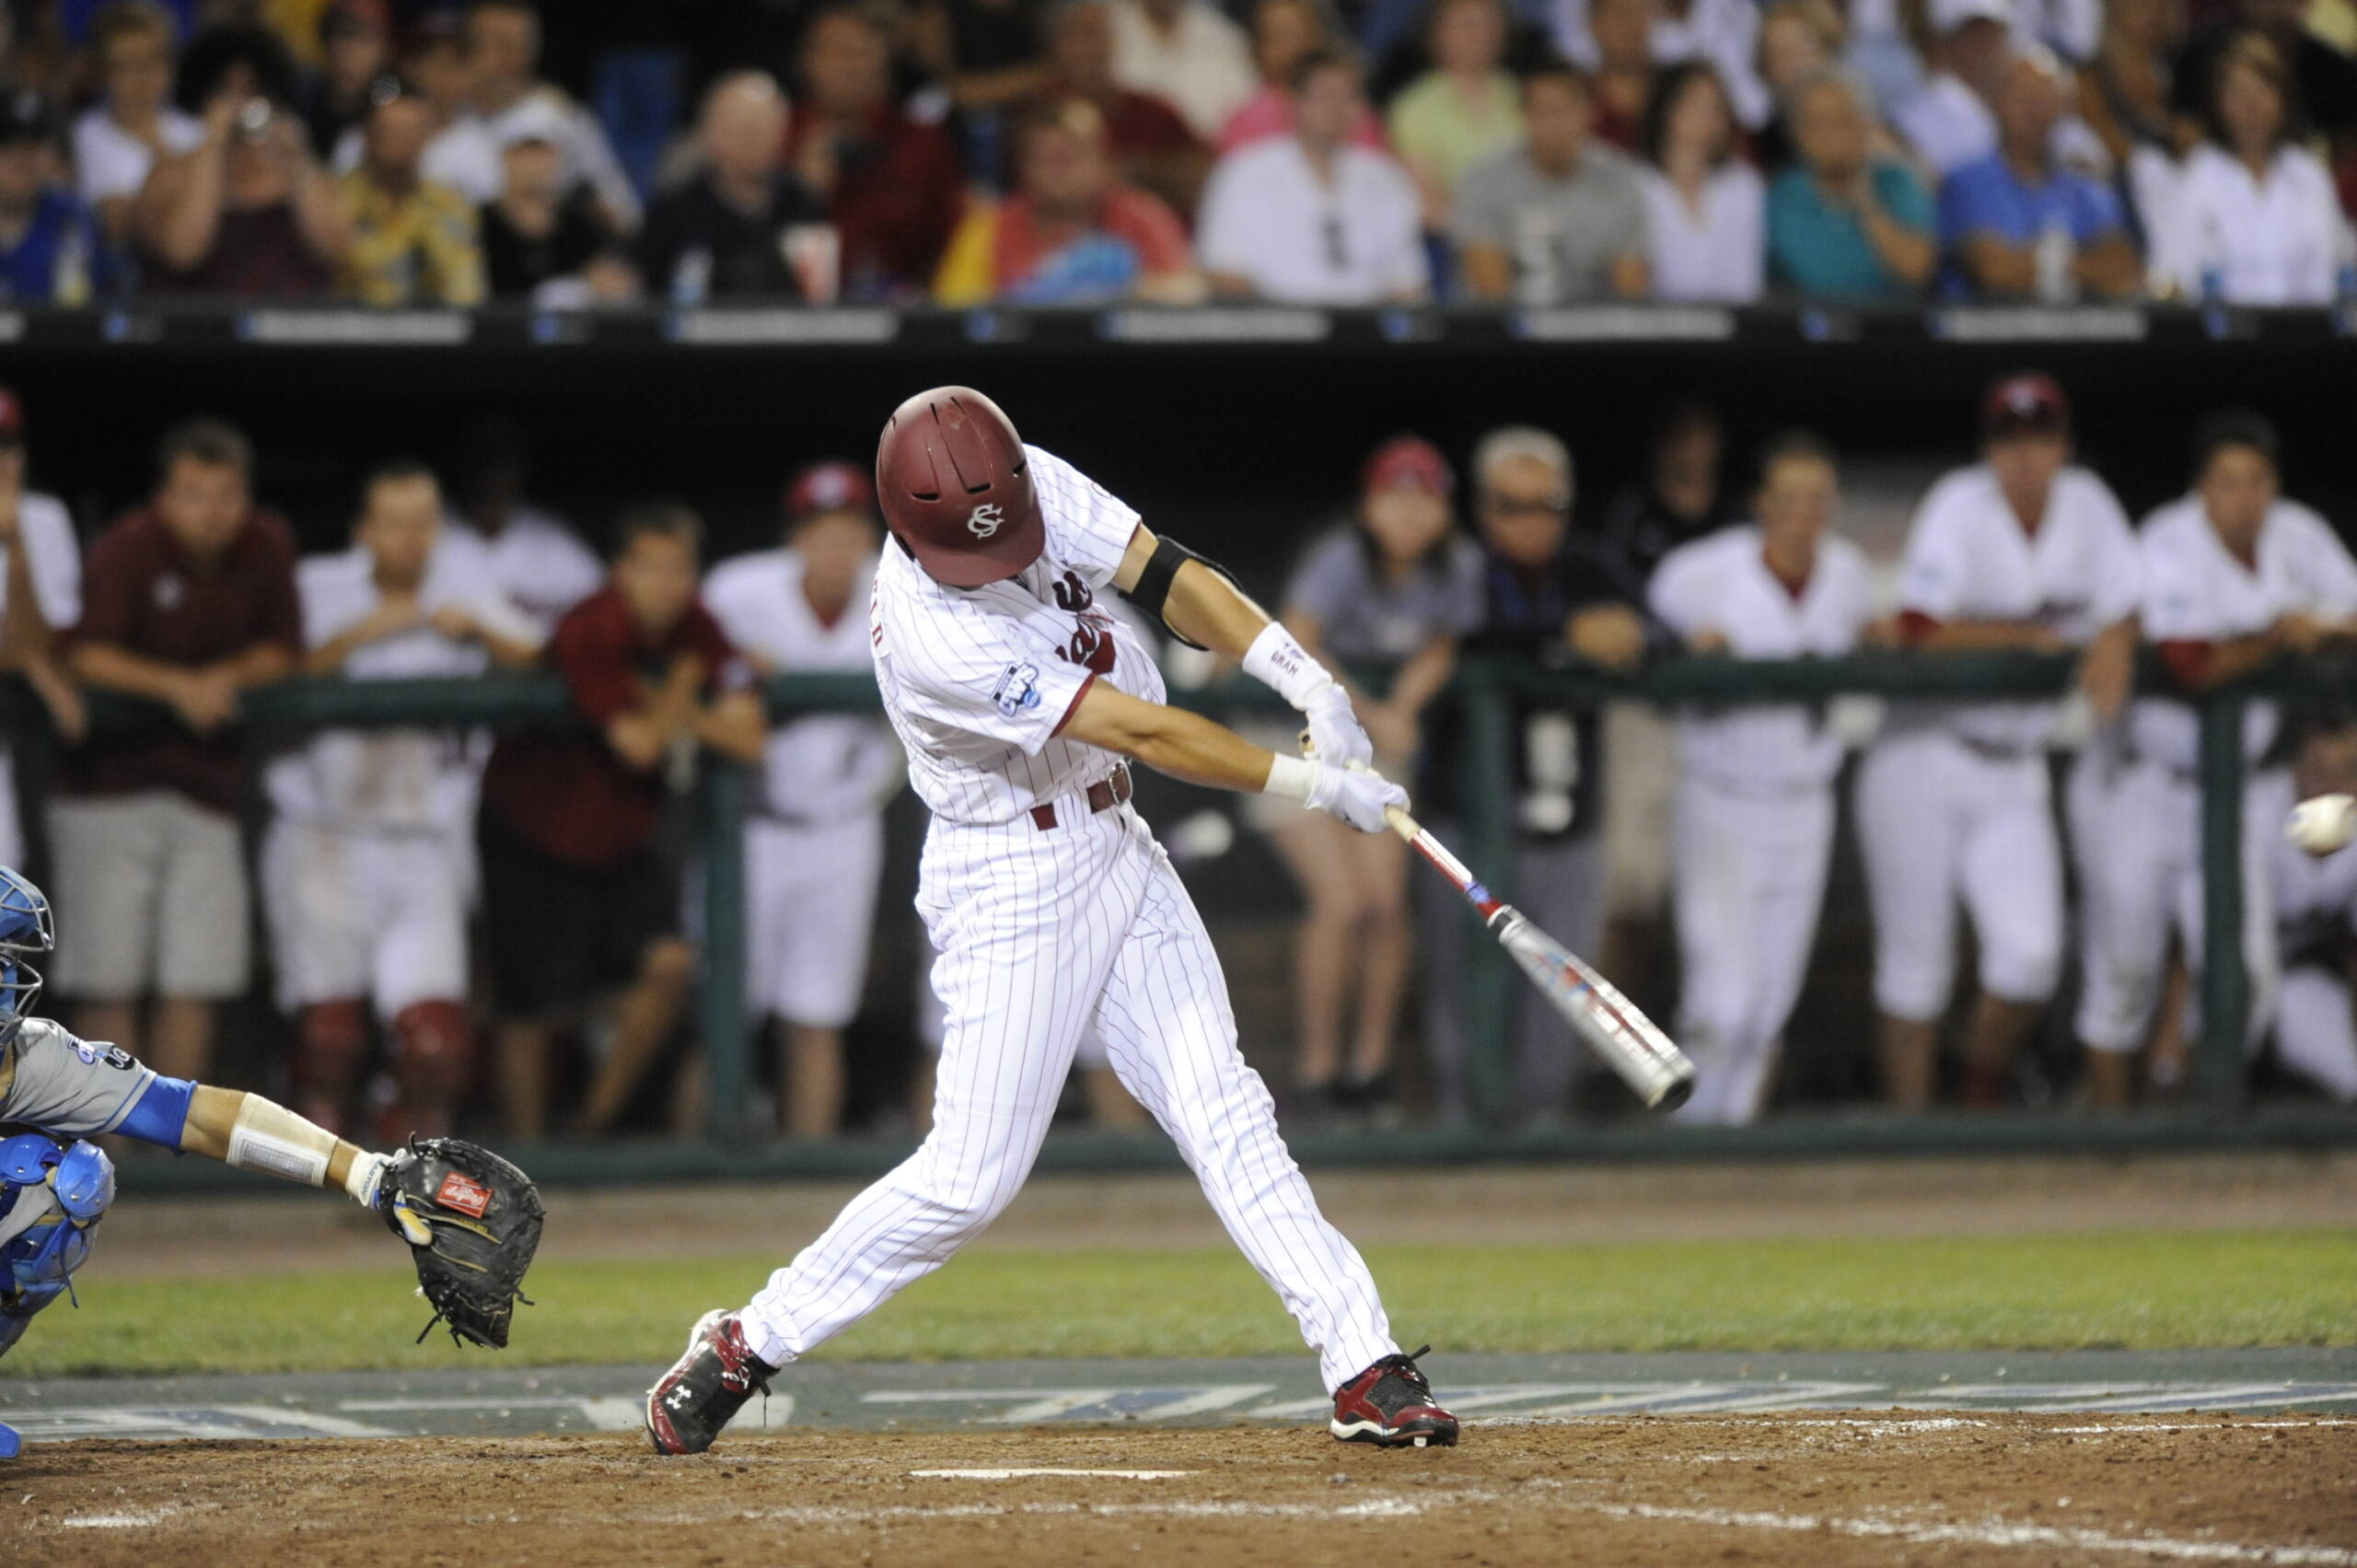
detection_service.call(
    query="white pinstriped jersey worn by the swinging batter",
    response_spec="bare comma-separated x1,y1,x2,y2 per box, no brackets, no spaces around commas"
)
870,446,1165,825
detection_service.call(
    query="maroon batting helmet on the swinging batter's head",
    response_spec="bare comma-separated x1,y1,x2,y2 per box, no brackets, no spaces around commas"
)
877,387,1047,587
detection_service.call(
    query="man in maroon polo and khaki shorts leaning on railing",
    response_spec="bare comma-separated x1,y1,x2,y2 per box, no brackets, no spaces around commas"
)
50,420,302,1077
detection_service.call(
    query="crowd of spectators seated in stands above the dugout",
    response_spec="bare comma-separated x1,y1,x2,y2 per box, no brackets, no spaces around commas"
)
0,0,2357,308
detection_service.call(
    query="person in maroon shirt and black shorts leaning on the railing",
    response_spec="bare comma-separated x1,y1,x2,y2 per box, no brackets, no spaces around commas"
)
476,505,763,1139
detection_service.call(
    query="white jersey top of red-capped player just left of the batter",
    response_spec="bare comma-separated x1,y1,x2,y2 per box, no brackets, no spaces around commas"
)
704,550,900,823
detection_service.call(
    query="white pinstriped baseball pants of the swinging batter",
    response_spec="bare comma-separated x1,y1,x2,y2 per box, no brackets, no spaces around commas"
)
742,795,1400,1388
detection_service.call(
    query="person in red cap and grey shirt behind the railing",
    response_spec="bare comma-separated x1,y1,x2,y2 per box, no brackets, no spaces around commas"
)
1275,436,1480,1113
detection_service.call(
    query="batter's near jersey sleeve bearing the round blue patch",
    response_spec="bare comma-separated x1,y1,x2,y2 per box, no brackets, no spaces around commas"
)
884,594,1096,757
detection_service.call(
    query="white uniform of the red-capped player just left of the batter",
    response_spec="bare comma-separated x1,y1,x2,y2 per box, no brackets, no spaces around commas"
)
704,550,900,1028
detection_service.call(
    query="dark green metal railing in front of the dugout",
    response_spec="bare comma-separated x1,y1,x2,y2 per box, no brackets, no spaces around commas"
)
0,651,2357,1177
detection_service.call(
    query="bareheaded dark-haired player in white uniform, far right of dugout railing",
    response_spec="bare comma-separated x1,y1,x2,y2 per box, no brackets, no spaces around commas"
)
2079,412,2357,1110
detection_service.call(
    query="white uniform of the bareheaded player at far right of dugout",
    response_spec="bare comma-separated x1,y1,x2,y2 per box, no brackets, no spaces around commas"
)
2079,497,2357,1051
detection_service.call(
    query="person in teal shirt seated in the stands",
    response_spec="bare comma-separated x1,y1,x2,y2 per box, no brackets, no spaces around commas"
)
1768,71,1940,304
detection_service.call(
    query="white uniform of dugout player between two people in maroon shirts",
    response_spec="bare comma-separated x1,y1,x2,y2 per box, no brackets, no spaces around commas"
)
261,545,538,1018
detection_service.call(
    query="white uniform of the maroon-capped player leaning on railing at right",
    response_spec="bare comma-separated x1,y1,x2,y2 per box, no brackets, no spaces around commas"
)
1857,464,2140,1021
